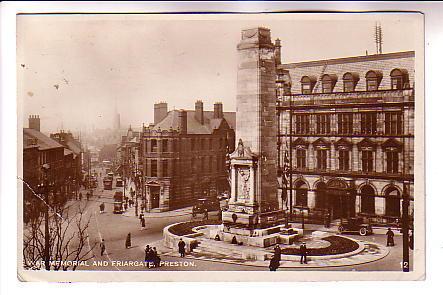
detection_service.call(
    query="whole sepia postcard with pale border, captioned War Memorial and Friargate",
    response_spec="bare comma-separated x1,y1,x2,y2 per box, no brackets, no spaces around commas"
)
15,12,425,282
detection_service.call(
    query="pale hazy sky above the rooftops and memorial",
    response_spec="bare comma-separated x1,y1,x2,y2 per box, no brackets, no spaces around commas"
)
17,14,422,132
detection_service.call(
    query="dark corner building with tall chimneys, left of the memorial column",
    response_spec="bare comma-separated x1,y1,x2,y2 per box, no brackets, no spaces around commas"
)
140,101,235,211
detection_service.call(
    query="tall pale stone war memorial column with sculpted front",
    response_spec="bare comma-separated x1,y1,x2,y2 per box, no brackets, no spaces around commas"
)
222,27,284,247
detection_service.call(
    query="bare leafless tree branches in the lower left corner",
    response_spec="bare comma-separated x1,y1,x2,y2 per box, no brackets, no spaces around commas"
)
23,206,97,270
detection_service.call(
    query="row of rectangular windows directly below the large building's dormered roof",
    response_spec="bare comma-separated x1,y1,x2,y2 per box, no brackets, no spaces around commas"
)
294,112,403,135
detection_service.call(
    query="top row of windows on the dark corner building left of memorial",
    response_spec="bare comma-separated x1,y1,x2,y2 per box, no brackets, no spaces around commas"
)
145,137,225,152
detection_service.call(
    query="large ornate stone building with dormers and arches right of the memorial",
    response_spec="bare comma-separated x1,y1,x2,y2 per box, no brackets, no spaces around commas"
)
275,40,415,223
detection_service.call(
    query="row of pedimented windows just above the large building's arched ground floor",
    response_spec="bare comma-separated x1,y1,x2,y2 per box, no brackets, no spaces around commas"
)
295,149,399,173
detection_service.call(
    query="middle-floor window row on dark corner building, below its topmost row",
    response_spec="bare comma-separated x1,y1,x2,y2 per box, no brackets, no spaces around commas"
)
145,157,226,177
